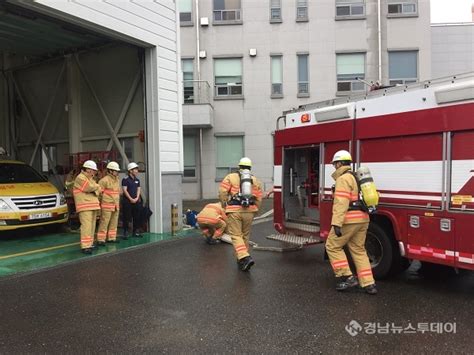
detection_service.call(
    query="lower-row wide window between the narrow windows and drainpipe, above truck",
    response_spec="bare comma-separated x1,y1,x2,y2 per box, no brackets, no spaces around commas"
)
336,53,365,92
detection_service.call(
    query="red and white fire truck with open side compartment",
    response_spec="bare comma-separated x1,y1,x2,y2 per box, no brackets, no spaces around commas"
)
273,72,474,279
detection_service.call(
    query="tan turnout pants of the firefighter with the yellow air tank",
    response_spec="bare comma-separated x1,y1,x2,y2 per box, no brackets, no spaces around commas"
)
326,223,375,287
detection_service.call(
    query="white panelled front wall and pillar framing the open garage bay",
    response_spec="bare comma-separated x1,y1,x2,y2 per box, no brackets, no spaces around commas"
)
22,0,183,232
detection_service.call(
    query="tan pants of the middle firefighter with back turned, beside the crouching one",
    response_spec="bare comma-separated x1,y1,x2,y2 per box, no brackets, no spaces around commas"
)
227,212,254,260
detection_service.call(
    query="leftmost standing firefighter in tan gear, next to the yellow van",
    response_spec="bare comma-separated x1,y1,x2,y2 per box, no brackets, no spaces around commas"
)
73,160,101,254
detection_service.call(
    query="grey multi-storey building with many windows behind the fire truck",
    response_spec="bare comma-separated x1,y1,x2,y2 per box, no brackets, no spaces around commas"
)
178,0,431,199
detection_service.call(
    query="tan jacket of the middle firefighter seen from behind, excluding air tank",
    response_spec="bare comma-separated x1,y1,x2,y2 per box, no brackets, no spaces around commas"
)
219,173,263,213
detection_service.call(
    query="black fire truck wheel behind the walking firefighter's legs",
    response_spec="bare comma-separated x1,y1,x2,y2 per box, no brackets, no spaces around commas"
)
365,223,397,280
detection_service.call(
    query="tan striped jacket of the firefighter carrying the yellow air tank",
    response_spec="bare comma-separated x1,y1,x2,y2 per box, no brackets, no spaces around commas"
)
331,166,370,227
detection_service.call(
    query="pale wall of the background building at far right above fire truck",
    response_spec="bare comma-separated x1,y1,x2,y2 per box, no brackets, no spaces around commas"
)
431,22,474,78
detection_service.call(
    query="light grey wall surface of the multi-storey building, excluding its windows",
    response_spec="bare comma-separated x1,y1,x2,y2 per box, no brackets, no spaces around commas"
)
181,0,431,199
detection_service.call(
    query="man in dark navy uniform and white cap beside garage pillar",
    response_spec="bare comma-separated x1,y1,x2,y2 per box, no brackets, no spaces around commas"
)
122,162,141,239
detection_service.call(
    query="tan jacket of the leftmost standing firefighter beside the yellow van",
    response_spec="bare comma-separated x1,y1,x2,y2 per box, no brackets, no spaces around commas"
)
72,172,100,212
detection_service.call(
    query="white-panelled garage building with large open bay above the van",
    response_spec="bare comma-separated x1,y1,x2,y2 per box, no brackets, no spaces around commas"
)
0,0,183,232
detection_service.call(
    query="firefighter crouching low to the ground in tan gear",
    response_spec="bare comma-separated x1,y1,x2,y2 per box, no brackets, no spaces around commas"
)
197,202,227,245
